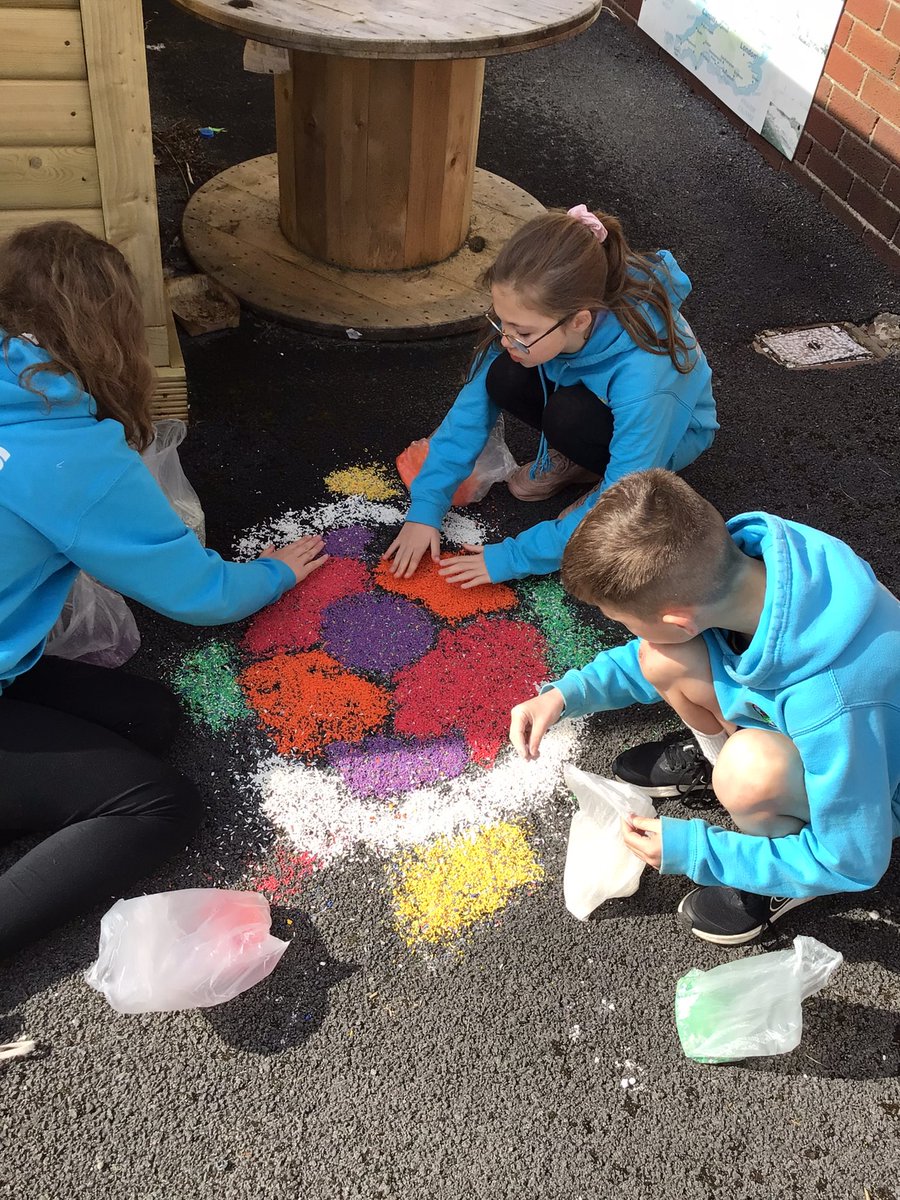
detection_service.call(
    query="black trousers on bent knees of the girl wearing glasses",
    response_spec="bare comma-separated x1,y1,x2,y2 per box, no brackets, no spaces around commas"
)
487,354,612,475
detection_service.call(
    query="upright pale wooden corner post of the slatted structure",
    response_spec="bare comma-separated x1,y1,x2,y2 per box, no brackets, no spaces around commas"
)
82,0,168,328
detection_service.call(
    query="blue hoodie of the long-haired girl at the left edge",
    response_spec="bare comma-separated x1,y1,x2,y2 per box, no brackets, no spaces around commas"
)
0,330,294,688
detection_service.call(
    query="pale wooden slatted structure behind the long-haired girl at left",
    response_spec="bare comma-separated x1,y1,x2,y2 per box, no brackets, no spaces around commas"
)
0,0,186,391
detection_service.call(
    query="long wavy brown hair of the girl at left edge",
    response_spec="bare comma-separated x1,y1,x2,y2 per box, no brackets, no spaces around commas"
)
0,221,155,450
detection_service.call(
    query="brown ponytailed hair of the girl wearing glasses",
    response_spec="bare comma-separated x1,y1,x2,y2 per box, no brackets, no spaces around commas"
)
469,212,696,377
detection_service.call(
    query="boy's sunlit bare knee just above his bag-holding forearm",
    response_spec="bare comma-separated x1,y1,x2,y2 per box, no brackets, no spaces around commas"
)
713,730,809,820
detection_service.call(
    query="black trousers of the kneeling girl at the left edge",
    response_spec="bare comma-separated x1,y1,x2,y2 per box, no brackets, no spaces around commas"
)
0,656,202,959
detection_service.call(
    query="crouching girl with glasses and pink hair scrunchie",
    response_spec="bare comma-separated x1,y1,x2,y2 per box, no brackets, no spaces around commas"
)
385,204,719,588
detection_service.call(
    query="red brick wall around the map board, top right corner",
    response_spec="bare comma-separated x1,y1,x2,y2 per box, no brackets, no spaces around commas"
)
605,0,900,270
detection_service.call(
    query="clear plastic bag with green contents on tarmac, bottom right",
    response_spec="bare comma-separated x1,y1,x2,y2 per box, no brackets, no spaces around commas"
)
676,937,844,1062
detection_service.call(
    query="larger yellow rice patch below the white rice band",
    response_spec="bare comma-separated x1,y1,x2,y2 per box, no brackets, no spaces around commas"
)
394,821,544,947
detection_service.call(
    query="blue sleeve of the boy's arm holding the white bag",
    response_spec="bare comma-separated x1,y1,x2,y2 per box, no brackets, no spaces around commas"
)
661,708,893,896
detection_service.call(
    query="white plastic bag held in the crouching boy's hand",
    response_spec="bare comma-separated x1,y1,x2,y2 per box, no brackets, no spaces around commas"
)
563,763,656,920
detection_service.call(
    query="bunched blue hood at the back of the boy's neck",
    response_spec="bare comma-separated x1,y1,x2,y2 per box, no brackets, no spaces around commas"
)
725,512,886,691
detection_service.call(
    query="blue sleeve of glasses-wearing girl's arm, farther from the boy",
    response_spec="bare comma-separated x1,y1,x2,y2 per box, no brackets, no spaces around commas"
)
407,353,500,529
